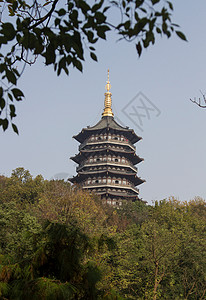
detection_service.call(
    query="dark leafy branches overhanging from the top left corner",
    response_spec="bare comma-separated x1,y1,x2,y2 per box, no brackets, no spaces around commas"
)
0,0,186,133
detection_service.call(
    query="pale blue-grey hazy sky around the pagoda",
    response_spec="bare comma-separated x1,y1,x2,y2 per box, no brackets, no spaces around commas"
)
0,0,206,203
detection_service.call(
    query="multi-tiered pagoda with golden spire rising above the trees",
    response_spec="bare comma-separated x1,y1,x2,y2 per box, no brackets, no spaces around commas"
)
69,70,144,206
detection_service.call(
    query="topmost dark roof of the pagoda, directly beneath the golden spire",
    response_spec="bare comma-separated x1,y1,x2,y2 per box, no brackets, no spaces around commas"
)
73,116,142,144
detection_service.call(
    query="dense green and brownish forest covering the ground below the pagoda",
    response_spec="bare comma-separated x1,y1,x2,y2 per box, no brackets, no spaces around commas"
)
0,168,206,300
